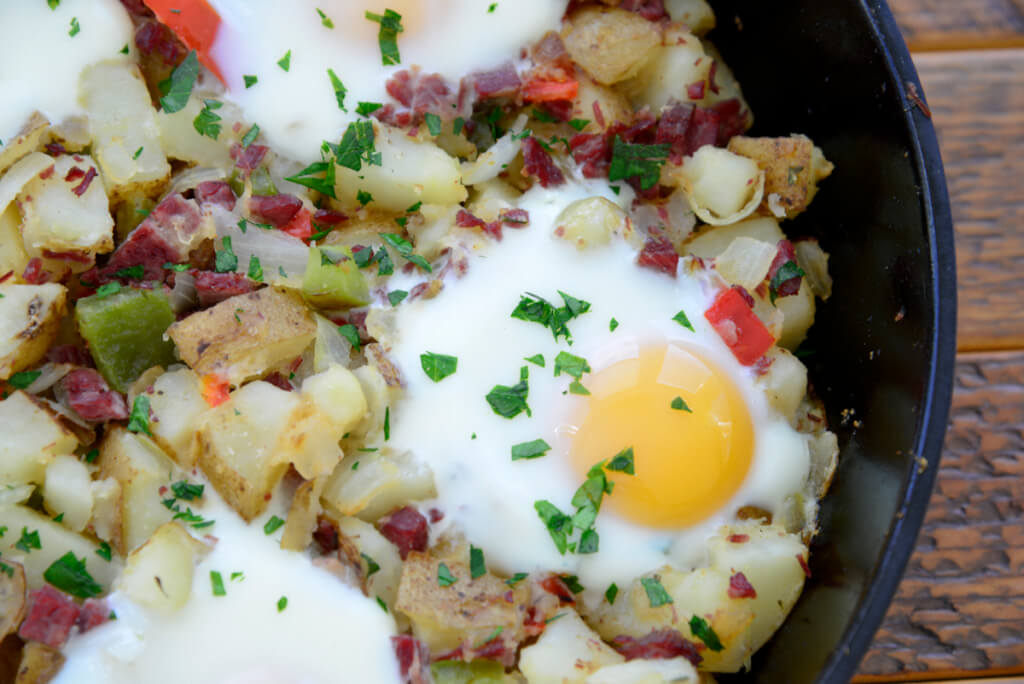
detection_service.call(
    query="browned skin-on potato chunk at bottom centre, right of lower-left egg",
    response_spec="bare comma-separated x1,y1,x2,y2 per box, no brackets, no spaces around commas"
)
394,546,529,653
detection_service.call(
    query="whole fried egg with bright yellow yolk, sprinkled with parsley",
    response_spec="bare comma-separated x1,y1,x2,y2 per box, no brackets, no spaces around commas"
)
388,181,809,592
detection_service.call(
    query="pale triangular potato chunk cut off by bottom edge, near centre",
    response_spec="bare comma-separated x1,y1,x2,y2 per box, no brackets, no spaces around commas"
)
519,608,626,684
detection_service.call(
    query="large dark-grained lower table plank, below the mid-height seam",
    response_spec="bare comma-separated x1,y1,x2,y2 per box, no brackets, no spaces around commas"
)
855,351,1024,682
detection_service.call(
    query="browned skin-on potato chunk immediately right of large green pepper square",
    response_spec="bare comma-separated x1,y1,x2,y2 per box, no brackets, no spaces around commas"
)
167,288,316,386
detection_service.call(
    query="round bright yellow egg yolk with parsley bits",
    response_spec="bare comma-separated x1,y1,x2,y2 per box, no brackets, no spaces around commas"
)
569,344,754,528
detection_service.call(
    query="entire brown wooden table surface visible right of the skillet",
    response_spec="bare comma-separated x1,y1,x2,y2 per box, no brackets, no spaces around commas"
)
855,0,1024,684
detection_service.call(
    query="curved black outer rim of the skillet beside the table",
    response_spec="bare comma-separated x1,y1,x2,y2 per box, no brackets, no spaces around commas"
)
817,0,956,682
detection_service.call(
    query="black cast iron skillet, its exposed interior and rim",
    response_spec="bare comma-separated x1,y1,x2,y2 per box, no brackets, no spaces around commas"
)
710,0,956,684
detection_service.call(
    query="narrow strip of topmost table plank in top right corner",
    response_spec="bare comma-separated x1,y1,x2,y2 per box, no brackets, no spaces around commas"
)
889,0,1024,51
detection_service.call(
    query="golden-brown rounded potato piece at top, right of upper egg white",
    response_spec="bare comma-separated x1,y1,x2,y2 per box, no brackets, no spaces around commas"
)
562,5,662,85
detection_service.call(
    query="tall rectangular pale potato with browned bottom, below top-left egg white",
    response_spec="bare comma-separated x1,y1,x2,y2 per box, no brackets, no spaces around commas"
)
79,61,171,198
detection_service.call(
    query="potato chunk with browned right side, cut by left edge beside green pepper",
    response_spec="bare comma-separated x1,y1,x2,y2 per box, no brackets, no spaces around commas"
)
0,283,68,378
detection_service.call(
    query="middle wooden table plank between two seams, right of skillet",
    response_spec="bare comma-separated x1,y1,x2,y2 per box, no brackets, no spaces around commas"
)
914,49,1024,350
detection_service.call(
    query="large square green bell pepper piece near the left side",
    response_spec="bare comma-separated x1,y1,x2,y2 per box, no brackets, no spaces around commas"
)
75,288,176,392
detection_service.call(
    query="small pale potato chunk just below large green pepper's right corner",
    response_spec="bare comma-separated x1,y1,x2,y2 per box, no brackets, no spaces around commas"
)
146,368,209,470
